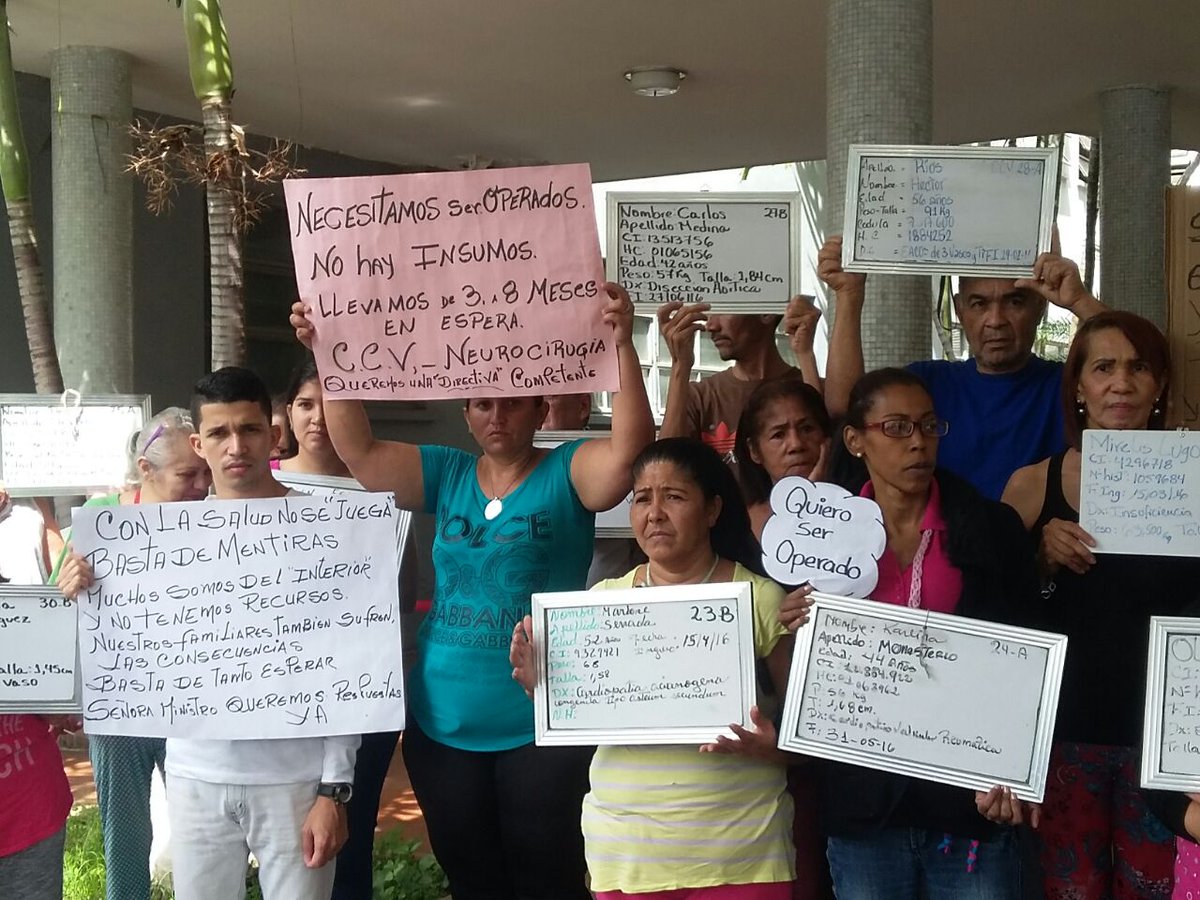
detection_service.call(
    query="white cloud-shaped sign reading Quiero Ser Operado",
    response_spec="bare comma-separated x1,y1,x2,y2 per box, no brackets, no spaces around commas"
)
762,475,888,598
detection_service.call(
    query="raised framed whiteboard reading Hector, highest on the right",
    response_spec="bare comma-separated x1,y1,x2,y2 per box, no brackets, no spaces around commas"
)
841,144,1058,278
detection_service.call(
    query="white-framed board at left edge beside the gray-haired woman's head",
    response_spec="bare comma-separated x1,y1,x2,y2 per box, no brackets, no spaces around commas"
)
0,394,150,497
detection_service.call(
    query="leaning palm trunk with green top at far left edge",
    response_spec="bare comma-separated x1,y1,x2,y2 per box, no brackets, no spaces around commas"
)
0,0,62,394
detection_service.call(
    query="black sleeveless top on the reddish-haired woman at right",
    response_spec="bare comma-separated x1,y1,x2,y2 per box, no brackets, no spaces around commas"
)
1032,454,1200,746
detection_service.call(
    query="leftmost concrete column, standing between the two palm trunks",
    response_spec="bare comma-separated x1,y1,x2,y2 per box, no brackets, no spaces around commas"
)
50,47,133,394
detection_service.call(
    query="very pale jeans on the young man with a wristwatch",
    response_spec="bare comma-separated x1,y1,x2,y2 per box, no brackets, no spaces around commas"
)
167,775,336,900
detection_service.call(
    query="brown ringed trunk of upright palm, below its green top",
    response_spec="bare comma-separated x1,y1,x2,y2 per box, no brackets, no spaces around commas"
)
203,96,246,370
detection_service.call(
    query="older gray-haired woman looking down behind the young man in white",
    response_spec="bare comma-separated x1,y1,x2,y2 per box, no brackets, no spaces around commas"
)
52,407,212,900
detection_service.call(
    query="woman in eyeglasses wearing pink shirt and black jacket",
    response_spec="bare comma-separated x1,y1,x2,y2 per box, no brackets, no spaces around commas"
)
780,368,1038,900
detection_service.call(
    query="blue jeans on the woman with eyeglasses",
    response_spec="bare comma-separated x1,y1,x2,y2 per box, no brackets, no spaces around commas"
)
828,828,1021,900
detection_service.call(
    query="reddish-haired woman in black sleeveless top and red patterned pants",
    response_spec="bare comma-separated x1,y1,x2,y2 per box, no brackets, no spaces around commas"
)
1003,311,1200,900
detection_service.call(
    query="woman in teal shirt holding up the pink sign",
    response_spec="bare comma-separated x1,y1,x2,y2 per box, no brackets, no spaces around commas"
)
292,284,654,900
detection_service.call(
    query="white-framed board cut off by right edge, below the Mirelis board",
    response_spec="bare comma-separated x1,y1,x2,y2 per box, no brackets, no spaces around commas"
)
1141,616,1200,791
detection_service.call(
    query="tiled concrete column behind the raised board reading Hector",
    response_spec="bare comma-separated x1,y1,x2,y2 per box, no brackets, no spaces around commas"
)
826,0,934,371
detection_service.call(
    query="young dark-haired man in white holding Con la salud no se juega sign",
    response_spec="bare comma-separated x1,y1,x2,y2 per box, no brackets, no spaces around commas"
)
60,367,359,900
